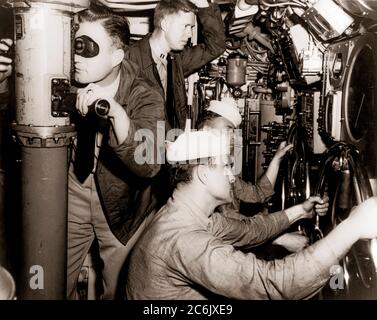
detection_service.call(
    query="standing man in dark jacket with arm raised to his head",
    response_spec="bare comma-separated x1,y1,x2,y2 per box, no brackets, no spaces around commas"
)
126,0,226,129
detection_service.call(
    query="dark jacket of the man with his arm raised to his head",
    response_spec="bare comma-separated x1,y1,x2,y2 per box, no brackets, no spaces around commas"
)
126,4,225,129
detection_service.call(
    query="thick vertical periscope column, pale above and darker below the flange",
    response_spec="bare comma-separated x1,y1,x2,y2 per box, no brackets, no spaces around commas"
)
11,0,89,300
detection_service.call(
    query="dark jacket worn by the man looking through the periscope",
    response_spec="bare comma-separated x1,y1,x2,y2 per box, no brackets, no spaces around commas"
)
72,60,164,244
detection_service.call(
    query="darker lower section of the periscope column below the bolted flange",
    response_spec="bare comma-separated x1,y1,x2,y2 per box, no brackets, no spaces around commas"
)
17,146,67,299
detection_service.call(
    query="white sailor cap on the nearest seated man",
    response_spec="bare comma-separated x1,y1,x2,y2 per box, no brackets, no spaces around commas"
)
166,131,230,162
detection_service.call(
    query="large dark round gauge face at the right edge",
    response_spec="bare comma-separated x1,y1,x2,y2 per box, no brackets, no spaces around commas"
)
346,47,377,141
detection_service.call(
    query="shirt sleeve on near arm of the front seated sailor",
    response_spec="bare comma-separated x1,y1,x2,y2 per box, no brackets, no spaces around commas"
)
170,232,338,299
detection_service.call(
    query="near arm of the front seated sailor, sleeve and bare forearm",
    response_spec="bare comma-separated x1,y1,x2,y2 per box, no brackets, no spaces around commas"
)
176,197,377,299
